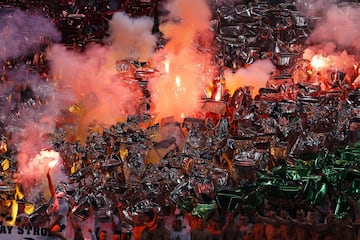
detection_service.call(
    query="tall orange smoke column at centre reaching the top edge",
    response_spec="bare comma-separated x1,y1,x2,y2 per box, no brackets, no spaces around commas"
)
149,0,214,121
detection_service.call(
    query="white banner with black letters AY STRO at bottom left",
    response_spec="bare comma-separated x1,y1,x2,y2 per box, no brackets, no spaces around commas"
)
0,225,49,240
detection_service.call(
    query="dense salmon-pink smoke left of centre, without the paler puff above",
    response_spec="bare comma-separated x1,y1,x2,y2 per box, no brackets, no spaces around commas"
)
51,45,141,136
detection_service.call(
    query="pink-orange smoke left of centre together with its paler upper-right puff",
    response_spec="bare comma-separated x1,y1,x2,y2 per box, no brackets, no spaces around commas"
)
50,13,156,139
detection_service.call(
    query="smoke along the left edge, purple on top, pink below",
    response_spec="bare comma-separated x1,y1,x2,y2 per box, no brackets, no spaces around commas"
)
0,8,64,201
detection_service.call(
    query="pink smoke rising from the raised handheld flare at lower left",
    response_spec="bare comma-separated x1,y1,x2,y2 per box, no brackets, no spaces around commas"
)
2,66,66,202
